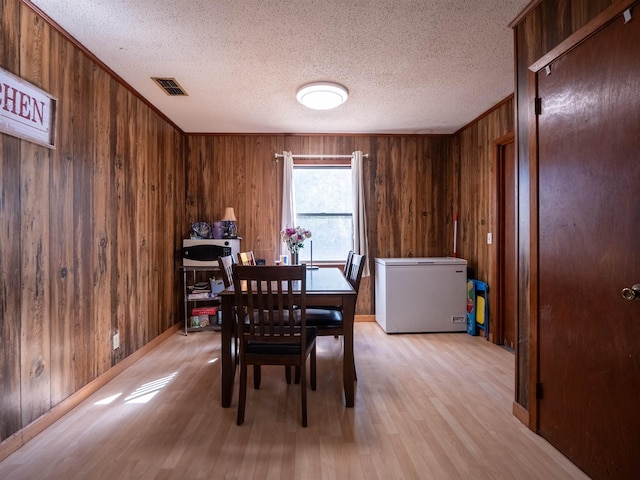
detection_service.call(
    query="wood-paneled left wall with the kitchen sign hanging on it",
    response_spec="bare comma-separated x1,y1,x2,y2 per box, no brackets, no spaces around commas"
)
0,0,184,441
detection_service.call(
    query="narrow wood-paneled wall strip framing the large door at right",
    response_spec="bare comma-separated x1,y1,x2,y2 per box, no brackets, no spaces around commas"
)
512,0,616,416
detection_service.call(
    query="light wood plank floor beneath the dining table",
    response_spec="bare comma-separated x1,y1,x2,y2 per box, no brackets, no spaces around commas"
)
0,322,587,480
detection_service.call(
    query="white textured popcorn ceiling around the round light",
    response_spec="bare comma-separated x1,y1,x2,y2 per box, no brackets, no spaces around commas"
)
31,0,529,133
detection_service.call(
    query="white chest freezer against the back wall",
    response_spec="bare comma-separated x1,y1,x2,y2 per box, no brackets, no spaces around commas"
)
375,257,467,333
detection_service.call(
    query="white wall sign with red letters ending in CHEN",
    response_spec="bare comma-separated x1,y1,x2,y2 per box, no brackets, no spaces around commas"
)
0,68,58,148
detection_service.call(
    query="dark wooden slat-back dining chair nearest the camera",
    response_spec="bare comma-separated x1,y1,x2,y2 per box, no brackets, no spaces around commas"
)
233,264,317,427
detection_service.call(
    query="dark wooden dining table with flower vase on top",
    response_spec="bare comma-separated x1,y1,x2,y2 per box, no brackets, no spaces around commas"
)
218,266,357,407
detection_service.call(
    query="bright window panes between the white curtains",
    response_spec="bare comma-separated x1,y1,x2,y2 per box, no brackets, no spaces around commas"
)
293,164,353,262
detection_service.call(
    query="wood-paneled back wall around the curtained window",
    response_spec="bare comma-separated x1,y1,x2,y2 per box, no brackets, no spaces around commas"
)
183,135,458,315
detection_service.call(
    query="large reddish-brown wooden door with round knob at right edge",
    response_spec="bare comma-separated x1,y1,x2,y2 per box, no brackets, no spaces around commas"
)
537,11,640,479
